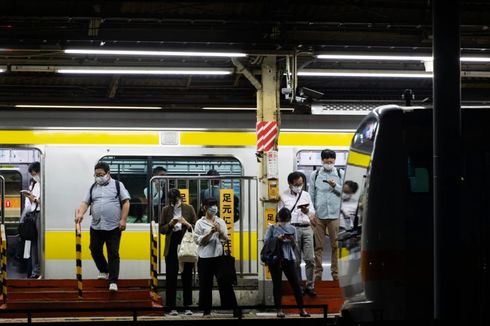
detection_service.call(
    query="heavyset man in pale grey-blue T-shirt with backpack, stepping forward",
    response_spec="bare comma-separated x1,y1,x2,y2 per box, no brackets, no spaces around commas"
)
75,162,130,291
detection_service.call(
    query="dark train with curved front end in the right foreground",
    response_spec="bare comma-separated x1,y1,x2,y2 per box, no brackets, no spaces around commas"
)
339,106,490,324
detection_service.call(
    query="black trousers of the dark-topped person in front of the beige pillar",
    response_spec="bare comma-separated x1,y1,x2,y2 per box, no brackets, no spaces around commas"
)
269,259,303,308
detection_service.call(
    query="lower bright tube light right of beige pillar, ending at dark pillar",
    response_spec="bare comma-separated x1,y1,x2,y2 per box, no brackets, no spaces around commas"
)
298,69,432,78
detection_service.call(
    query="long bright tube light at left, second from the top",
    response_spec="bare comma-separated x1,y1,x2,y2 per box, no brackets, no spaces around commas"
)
56,67,233,75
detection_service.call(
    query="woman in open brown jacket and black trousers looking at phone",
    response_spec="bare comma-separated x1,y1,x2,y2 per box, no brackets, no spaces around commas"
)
159,189,197,316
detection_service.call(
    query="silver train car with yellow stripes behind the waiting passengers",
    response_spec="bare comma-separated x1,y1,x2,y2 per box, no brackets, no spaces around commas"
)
0,111,360,279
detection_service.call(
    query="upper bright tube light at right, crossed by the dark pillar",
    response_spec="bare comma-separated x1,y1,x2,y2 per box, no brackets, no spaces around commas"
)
316,54,490,62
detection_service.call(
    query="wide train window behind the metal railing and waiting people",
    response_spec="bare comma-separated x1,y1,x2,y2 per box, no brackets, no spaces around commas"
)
100,156,243,223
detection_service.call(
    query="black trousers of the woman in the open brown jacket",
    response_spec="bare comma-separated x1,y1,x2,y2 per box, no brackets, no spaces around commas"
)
165,231,194,307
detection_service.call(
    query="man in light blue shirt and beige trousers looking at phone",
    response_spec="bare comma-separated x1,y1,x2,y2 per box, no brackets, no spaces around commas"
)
309,149,344,280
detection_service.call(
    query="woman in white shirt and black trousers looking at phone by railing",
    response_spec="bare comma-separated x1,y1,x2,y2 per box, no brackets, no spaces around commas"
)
194,197,237,315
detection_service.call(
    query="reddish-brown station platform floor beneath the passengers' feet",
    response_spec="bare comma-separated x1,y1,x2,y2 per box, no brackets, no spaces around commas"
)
0,280,342,325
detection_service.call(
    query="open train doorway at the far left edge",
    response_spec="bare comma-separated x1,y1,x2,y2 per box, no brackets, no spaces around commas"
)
0,148,44,279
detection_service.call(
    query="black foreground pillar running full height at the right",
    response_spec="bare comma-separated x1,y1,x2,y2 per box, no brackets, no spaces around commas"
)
432,0,462,324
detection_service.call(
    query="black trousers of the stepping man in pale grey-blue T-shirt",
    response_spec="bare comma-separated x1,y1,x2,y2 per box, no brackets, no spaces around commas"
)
90,228,121,283
